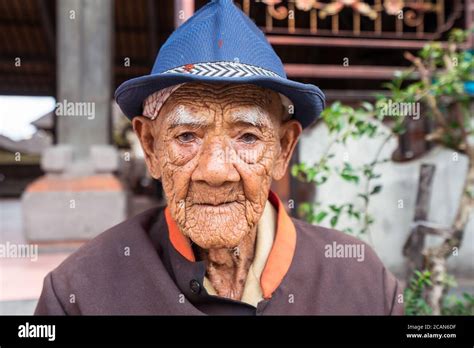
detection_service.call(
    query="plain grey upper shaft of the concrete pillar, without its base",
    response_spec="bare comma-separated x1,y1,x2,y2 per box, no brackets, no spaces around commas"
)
57,0,113,157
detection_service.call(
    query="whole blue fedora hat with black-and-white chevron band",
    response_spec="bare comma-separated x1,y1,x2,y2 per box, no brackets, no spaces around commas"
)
115,0,324,128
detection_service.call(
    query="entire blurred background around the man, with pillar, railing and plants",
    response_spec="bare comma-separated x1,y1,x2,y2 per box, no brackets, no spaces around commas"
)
0,0,474,314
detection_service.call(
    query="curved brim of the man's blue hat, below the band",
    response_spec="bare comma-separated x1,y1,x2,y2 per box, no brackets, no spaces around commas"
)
115,73,325,128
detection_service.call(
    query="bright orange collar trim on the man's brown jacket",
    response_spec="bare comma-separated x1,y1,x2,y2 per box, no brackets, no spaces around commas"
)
165,191,296,298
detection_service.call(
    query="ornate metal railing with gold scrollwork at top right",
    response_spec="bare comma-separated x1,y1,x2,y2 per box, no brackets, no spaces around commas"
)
236,0,464,40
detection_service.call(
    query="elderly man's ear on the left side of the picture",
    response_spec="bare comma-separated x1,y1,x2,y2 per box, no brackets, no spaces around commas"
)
132,116,161,179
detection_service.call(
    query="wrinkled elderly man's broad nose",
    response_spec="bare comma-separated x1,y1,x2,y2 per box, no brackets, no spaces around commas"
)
192,145,240,186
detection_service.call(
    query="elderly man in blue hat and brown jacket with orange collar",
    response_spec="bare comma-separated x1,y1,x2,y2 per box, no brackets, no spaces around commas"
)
36,0,402,315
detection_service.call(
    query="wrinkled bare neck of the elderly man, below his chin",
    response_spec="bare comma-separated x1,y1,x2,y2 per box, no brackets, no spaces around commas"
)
199,226,257,300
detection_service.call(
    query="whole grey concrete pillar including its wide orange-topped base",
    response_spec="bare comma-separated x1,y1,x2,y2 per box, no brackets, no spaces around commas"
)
22,0,126,241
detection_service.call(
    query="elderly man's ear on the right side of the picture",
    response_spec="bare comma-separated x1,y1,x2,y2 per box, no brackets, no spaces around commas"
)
273,120,303,180
